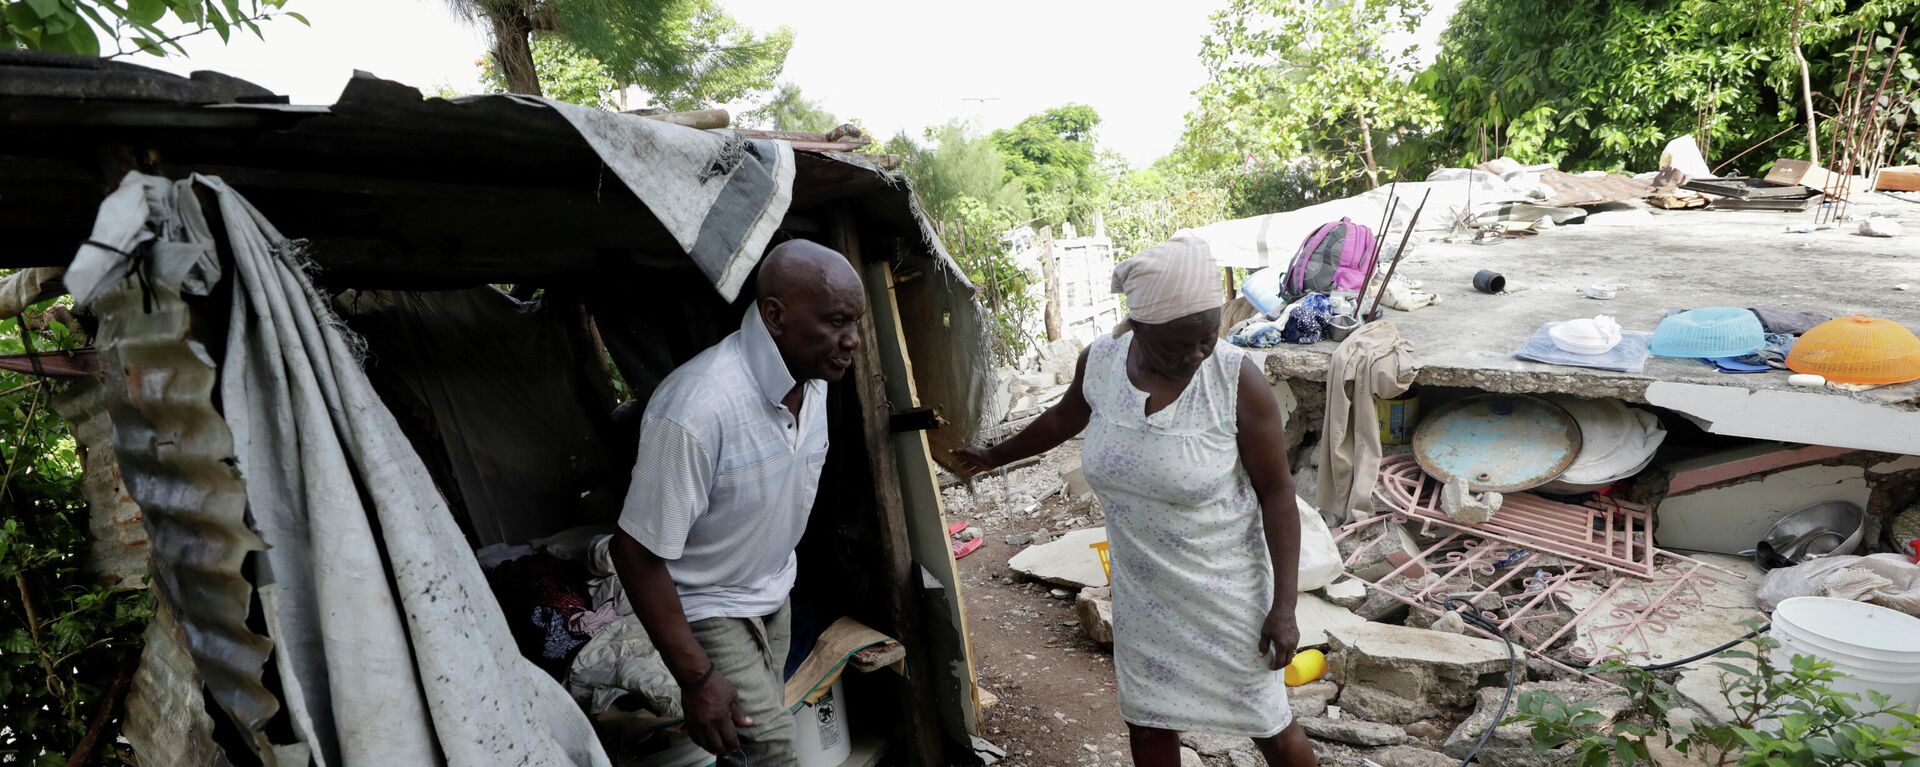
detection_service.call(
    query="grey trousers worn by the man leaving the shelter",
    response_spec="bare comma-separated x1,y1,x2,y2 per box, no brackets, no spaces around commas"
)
689,604,799,767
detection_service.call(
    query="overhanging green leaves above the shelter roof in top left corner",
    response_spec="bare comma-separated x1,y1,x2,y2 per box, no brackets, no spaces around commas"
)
0,0,307,58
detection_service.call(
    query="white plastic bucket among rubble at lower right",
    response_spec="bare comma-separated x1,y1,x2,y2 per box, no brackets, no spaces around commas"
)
1768,596,1920,727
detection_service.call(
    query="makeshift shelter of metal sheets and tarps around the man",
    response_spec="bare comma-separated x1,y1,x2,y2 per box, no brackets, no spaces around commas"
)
0,52,989,765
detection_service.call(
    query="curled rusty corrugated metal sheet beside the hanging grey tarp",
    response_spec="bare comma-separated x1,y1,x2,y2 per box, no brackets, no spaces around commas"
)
92,269,280,730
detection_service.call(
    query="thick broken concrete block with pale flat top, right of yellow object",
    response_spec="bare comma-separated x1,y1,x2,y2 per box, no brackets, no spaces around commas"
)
1329,623,1507,725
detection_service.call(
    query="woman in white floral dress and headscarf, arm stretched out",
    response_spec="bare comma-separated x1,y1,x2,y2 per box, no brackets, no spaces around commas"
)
956,236,1315,767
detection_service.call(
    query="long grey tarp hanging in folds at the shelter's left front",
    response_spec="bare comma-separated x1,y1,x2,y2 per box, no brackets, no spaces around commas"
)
69,173,609,765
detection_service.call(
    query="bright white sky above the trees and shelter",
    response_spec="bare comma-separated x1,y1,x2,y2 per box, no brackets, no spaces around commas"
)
129,0,1459,165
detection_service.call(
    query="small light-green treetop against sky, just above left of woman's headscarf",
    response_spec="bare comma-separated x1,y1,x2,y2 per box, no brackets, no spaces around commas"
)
993,104,1106,229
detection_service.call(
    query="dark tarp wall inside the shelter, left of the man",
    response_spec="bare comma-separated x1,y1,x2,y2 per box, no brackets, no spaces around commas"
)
334,286,614,548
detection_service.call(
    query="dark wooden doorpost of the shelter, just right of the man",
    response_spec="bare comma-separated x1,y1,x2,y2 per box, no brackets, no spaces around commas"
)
828,208,945,767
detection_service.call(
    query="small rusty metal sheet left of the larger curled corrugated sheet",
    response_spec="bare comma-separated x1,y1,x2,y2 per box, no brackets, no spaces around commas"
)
54,379,148,588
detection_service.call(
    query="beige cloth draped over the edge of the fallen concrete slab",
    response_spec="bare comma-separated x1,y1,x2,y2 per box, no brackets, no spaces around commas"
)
1319,321,1419,519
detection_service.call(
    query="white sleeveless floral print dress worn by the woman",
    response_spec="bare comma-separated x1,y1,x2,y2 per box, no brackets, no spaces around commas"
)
1081,333,1292,738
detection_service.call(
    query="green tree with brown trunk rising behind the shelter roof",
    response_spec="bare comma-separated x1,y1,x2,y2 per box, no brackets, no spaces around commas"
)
447,0,793,110
